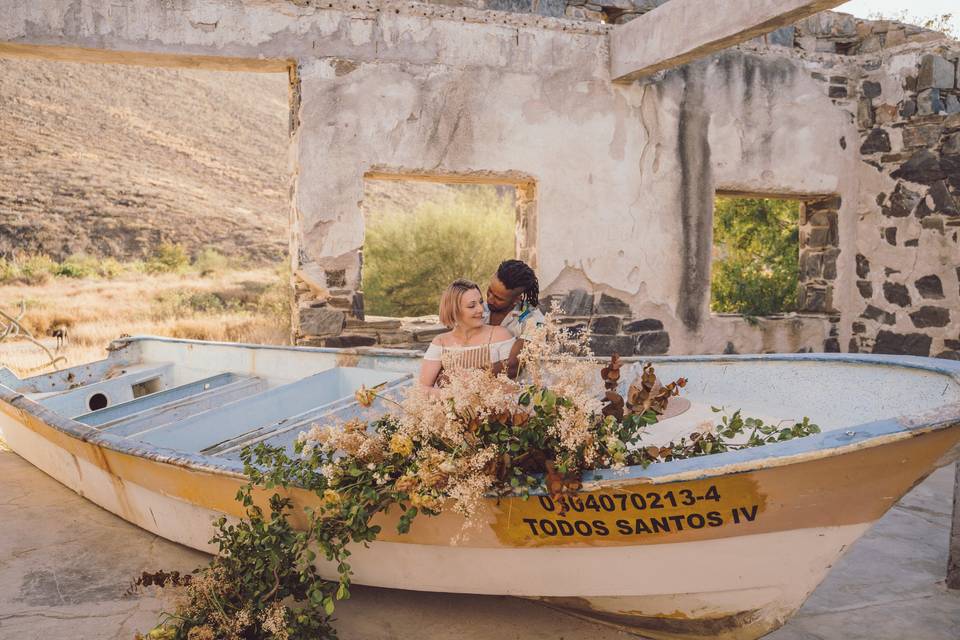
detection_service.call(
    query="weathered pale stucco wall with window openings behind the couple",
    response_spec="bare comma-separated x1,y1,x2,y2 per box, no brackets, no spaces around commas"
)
296,41,857,352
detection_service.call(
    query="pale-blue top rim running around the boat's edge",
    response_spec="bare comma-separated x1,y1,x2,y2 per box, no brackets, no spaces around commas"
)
0,336,960,493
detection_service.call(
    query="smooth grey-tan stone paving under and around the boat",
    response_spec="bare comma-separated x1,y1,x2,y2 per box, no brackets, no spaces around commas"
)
0,447,960,640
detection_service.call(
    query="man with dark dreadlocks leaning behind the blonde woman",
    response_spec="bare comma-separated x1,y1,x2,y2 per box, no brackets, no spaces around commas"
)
484,260,544,378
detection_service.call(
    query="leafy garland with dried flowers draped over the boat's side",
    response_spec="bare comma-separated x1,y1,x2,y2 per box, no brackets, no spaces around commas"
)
135,336,819,640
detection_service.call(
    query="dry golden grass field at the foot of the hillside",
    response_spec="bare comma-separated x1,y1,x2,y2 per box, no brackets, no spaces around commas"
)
0,267,290,377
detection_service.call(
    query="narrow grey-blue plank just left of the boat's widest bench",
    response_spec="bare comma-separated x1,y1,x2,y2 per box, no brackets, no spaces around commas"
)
99,377,267,438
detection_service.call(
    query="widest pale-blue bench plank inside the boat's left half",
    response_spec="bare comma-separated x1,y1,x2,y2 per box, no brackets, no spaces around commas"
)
129,367,405,453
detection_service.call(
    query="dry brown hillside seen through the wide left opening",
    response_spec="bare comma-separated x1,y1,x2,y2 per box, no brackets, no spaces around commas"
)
0,59,289,261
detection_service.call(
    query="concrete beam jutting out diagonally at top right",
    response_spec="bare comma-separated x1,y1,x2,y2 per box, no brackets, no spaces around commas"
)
610,0,844,82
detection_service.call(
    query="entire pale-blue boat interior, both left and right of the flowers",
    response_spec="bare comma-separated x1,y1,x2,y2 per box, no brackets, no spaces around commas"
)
11,338,960,476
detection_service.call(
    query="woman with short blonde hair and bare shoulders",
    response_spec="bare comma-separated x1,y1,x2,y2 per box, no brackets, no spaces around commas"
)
420,279,514,387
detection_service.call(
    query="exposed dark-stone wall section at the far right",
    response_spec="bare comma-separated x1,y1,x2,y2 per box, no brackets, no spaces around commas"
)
848,43,960,359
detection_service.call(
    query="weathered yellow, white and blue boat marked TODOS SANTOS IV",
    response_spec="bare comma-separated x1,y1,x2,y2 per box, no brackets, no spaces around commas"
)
0,336,960,640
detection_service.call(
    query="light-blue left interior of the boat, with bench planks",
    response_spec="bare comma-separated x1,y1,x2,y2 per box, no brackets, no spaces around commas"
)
34,363,413,460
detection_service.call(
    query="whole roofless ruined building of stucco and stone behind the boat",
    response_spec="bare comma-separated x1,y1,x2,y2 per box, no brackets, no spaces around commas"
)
0,0,960,358
